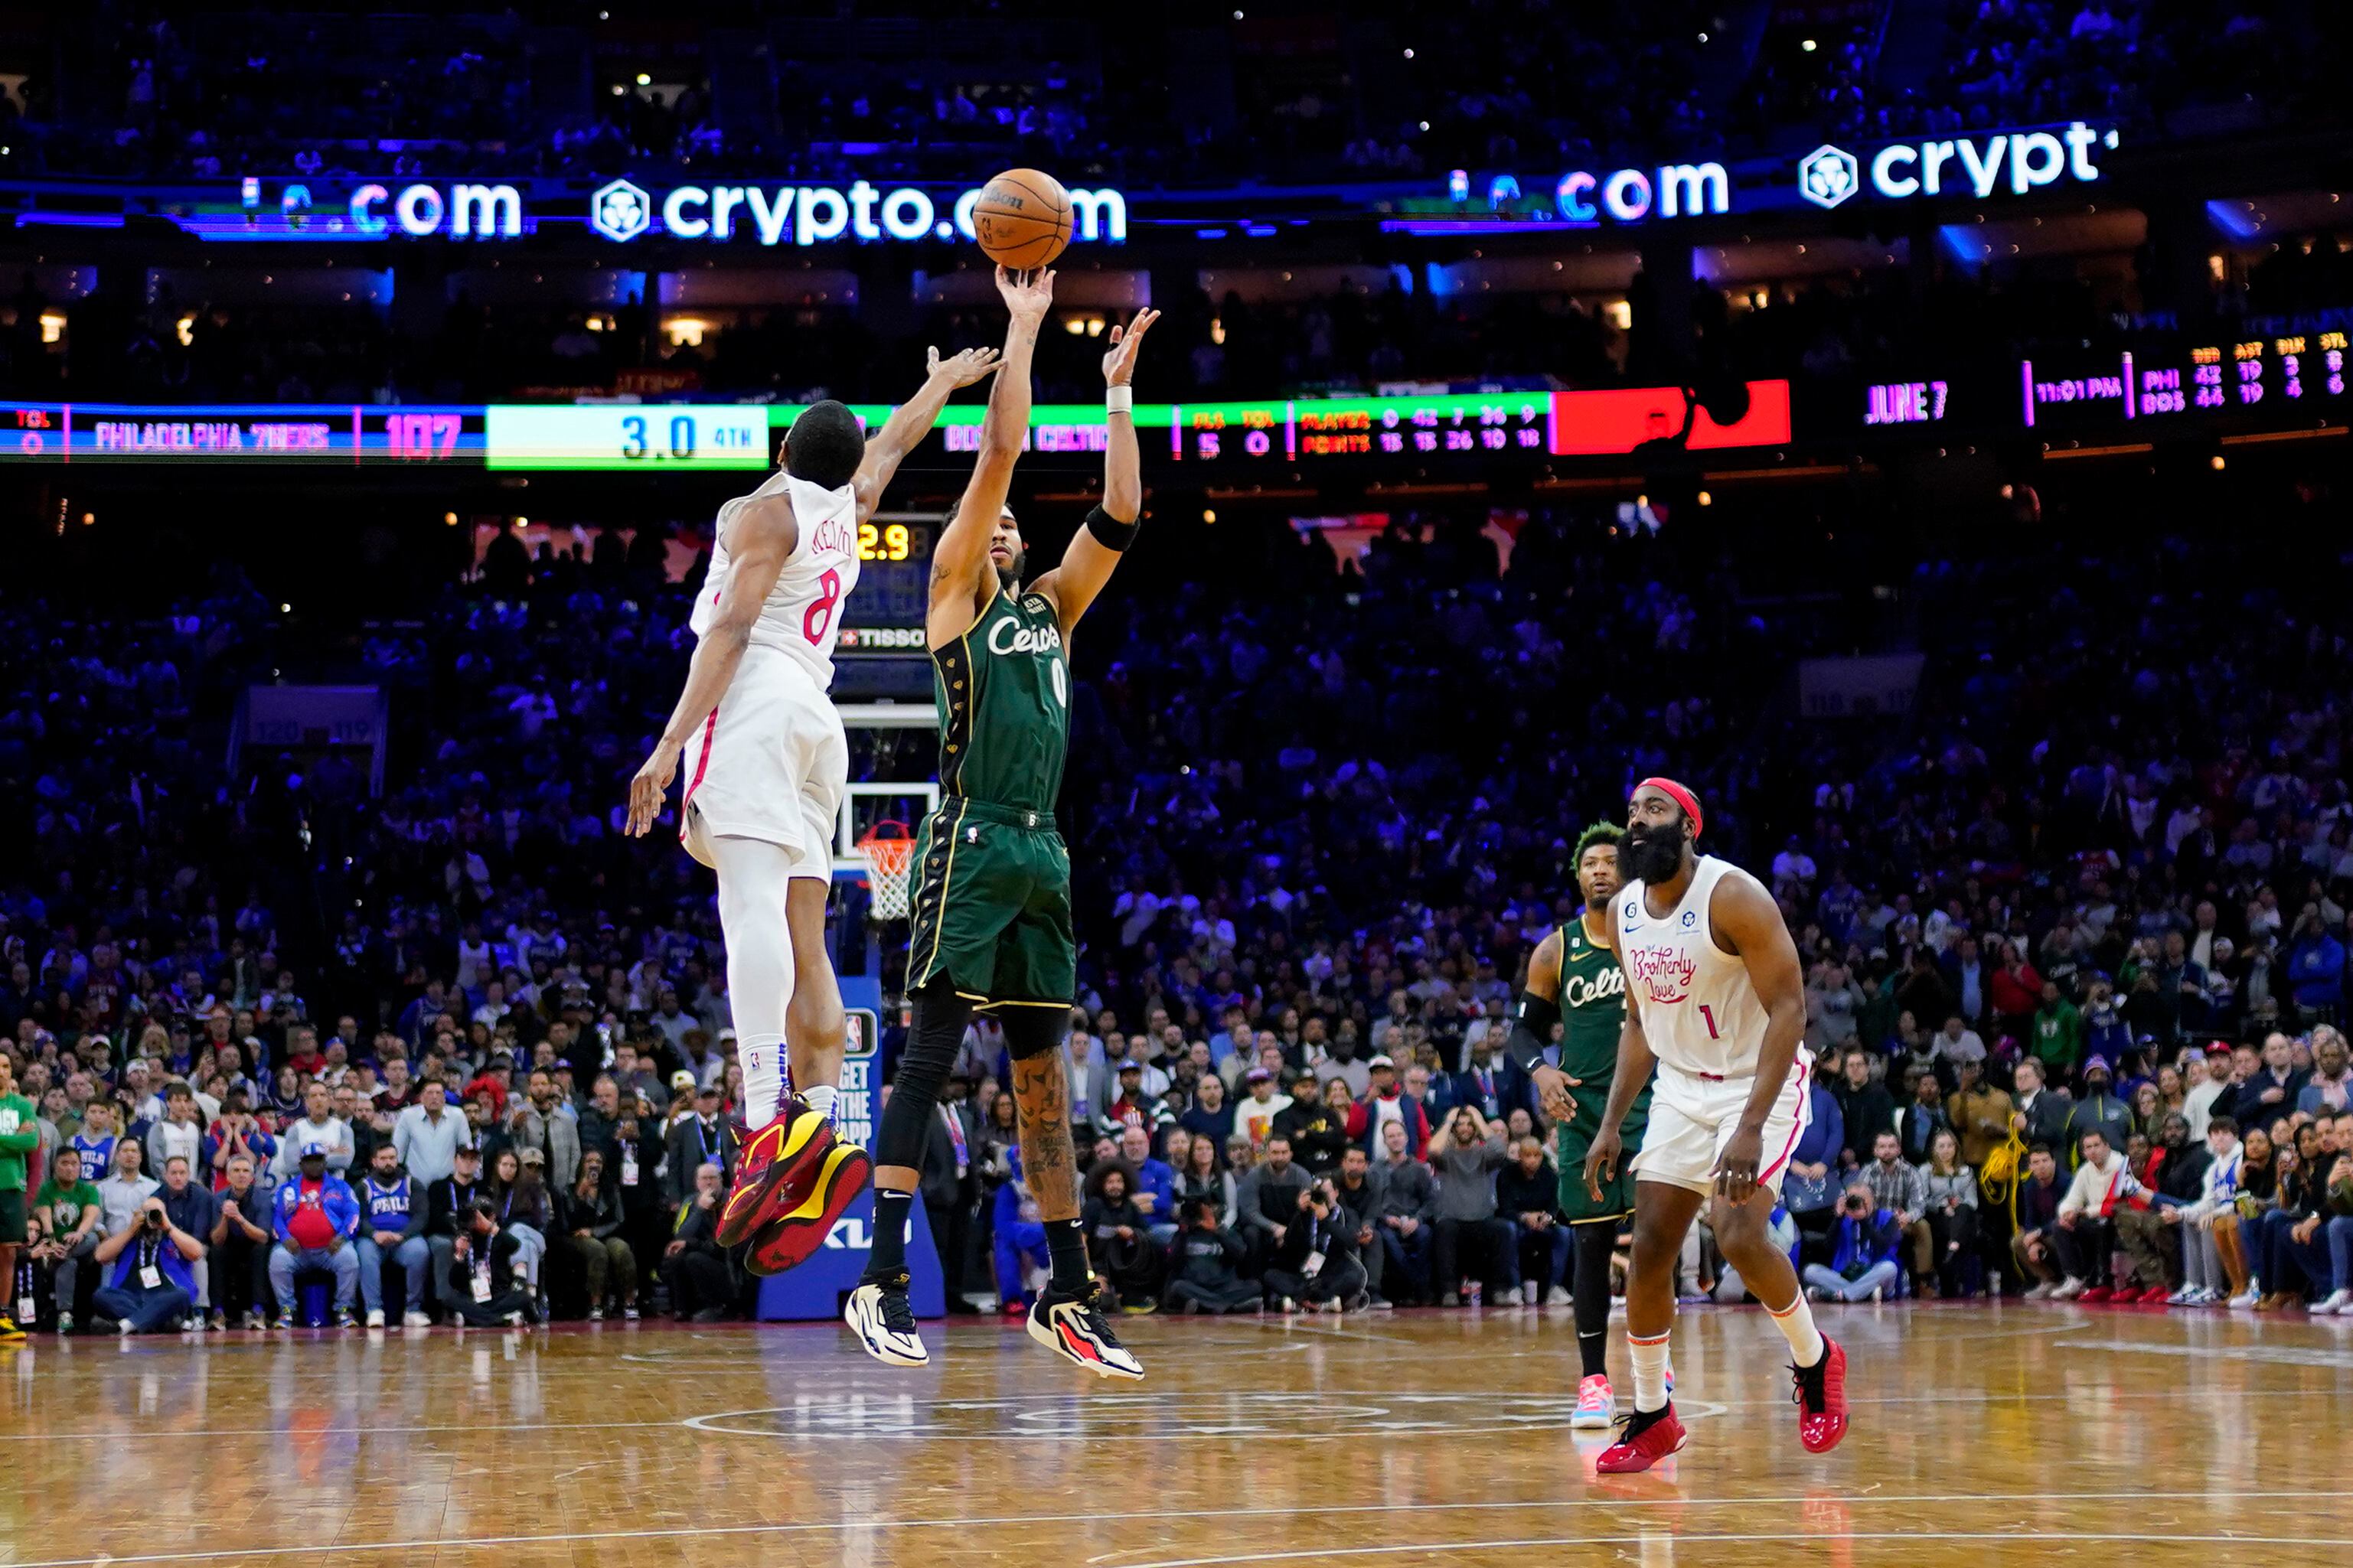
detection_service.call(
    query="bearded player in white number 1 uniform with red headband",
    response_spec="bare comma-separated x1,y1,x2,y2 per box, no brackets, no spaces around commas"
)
1586,778,1847,1474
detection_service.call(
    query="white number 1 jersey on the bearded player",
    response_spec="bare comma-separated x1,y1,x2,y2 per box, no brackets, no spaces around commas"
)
1617,856,1765,1079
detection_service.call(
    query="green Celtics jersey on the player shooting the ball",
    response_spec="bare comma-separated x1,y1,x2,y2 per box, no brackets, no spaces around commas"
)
932,592,1071,813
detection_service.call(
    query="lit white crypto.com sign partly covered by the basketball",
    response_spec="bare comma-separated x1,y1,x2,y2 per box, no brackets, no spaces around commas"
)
589,178,1127,244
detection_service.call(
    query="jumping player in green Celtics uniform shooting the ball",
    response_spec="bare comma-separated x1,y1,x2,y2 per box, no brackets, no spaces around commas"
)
842,268,1157,1377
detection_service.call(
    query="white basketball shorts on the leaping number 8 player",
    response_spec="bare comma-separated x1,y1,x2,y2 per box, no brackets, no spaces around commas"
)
677,642,850,879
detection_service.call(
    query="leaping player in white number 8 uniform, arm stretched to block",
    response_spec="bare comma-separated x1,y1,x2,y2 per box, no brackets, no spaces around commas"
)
628,348,995,1274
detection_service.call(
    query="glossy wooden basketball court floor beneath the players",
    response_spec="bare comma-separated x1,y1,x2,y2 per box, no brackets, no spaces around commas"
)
0,1305,2353,1568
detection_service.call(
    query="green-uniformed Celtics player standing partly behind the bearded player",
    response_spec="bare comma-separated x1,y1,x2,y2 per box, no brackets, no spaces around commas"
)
1506,823,1650,1427
